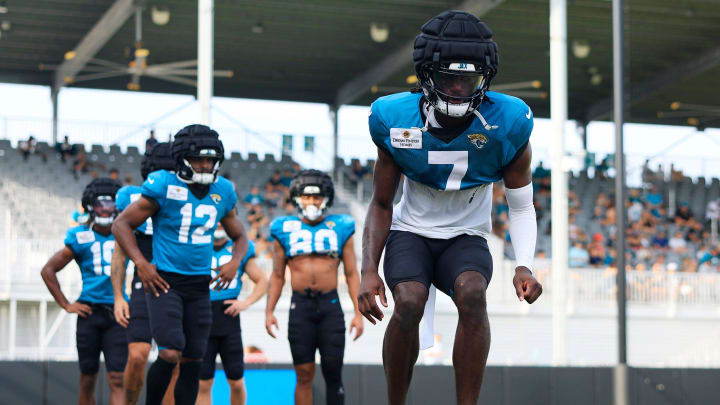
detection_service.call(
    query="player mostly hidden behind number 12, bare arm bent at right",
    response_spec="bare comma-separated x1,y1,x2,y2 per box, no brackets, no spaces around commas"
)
196,224,268,405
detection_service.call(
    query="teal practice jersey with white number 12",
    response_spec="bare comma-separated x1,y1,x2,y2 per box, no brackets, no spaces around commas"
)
142,170,237,276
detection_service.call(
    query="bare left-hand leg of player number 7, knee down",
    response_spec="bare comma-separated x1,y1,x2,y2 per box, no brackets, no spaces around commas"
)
383,281,428,405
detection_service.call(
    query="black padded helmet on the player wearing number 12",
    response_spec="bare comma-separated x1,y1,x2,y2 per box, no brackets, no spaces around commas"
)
172,124,225,185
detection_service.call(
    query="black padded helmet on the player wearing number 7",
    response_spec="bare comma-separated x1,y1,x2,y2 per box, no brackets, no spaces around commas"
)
413,11,499,117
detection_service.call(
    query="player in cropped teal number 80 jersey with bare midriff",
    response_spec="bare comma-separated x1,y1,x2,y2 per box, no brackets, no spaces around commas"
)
265,170,363,405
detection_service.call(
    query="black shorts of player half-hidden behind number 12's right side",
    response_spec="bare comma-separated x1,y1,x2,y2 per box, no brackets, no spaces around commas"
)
200,300,245,380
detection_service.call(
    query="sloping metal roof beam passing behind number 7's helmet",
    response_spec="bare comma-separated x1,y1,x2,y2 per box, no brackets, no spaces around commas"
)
335,0,505,106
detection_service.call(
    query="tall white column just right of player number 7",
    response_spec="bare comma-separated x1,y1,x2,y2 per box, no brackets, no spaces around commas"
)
550,0,568,366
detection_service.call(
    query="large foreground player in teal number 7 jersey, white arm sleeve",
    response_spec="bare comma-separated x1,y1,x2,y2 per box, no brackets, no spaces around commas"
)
359,11,542,405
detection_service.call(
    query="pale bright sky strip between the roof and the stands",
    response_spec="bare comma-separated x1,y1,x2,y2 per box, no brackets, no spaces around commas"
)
0,83,720,183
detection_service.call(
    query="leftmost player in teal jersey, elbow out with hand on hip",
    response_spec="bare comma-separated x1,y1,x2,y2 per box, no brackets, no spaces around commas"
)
40,178,127,405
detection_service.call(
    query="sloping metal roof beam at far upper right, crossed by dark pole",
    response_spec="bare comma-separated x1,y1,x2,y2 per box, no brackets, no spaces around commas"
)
585,47,720,122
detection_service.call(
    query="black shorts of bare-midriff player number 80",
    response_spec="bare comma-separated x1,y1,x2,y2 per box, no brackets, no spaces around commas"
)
288,289,345,364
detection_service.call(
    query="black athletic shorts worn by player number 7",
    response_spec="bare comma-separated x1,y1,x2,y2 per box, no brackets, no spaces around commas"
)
383,231,492,297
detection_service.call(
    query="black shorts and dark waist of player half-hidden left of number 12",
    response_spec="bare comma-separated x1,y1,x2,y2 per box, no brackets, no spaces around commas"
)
127,232,152,344
